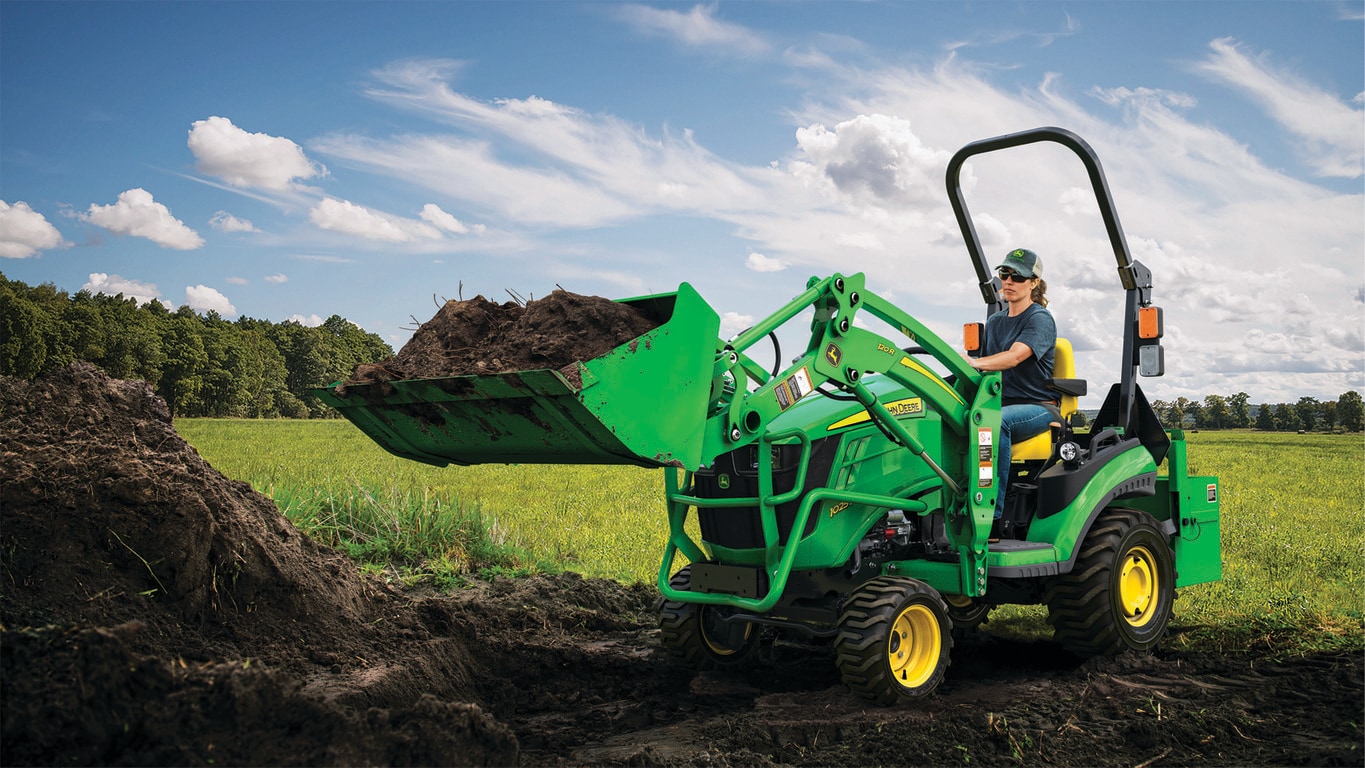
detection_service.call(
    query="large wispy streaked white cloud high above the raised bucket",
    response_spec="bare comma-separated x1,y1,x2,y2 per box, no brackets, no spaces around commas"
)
311,60,773,228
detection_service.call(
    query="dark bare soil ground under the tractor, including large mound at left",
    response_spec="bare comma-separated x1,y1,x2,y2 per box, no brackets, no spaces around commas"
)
0,363,1365,767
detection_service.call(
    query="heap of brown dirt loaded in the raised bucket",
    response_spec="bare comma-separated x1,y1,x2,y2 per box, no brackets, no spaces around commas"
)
345,289,659,385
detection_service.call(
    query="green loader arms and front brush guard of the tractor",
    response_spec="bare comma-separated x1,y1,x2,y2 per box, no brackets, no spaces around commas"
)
658,273,1001,612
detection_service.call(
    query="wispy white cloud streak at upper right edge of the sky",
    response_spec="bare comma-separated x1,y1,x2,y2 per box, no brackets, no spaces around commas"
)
1198,38,1365,179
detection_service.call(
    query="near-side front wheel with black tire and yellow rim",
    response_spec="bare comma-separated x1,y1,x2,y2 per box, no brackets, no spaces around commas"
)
834,576,953,705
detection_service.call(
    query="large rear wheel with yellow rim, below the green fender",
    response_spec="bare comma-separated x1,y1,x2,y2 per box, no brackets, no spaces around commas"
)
1047,507,1175,656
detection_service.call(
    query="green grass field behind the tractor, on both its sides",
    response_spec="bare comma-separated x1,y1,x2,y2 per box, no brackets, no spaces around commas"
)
176,419,1365,649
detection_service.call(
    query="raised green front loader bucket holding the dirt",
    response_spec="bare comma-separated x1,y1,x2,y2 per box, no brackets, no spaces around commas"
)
314,282,721,469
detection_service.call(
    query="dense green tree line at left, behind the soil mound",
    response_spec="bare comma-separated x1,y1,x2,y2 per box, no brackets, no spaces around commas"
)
0,274,393,419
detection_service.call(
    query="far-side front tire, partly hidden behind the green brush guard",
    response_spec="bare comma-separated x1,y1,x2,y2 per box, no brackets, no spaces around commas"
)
659,566,763,670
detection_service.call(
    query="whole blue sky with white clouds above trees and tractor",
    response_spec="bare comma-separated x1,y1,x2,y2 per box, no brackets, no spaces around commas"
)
0,0,1365,407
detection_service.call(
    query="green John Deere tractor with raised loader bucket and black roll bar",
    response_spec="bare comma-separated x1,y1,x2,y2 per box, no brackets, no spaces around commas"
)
318,128,1222,704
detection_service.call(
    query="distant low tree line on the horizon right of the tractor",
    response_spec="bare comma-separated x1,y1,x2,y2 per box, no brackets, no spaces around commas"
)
1152,390,1365,432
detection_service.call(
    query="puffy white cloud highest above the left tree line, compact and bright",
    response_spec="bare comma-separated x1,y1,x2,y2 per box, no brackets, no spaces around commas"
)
188,117,328,191
